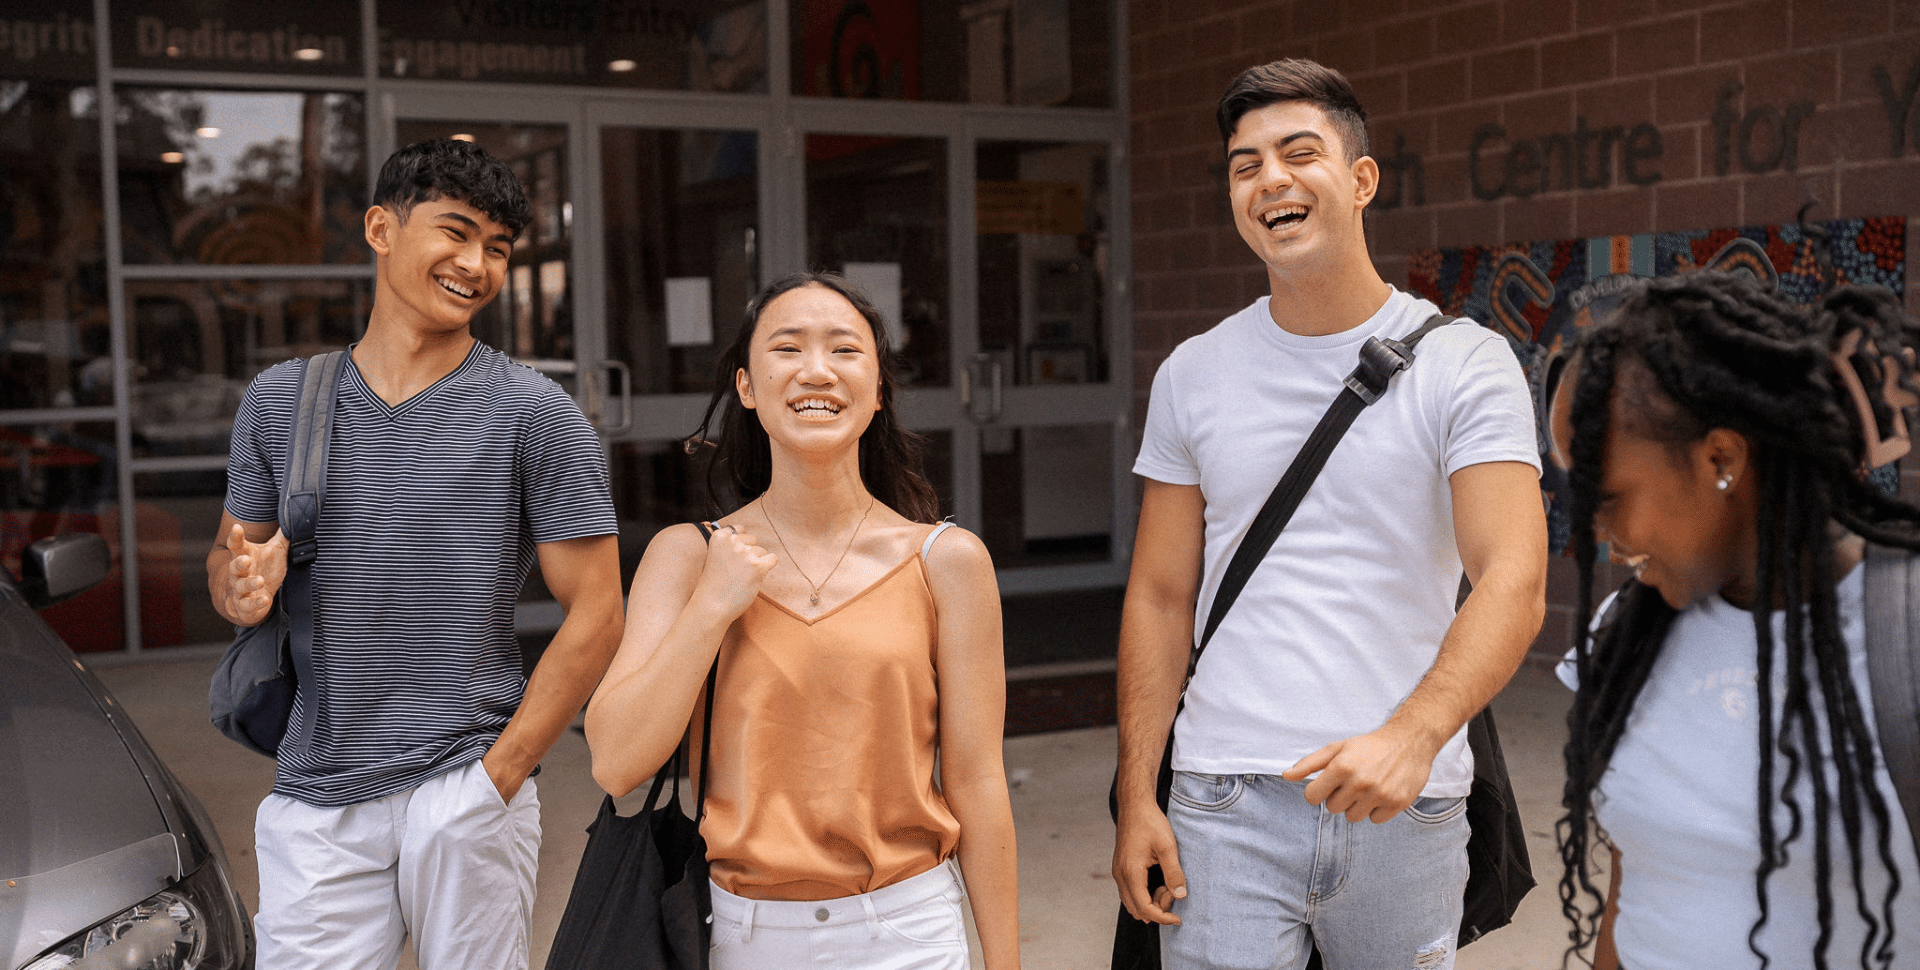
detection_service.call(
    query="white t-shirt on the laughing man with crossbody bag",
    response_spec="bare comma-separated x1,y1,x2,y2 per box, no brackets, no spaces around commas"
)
1133,290,1540,797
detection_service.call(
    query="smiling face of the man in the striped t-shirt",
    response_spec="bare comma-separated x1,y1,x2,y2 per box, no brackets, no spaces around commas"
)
367,198,515,332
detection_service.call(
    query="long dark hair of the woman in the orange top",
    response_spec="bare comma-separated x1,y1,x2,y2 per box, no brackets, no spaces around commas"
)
685,273,941,522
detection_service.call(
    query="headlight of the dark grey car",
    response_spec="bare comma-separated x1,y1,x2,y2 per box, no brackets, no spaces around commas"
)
21,861,246,970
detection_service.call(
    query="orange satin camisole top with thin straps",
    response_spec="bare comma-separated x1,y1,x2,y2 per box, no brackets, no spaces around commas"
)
695,526,960,901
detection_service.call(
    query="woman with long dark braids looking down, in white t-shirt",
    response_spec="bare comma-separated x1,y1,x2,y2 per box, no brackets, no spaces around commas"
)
1551,273,1920,970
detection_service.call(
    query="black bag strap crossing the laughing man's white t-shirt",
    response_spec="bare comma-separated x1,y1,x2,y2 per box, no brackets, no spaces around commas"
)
1192,313,1457,663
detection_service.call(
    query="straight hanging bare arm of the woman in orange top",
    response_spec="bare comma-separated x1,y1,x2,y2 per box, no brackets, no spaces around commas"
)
927,528,1020,970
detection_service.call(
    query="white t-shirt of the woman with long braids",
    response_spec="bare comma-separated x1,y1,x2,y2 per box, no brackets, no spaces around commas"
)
1561,567,1920,970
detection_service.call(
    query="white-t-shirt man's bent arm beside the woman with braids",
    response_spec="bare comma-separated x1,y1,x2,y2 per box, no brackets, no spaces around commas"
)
1283,461,1548,822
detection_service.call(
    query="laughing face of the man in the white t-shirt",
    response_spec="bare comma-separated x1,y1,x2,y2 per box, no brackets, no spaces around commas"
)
1227,102,1380,292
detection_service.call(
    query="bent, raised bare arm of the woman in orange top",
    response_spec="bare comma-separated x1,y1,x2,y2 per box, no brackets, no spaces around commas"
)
588,524,774,795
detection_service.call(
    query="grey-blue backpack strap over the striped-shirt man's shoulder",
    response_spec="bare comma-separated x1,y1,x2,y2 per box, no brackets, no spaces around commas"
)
280,350,346,749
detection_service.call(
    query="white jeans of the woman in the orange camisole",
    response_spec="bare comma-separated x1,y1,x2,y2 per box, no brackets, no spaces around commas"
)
710,861,968,970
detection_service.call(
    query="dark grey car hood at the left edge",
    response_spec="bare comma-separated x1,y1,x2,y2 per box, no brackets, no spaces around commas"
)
0,588,180,966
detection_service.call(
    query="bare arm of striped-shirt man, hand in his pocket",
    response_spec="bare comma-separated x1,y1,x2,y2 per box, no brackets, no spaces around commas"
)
480,536,620,801
